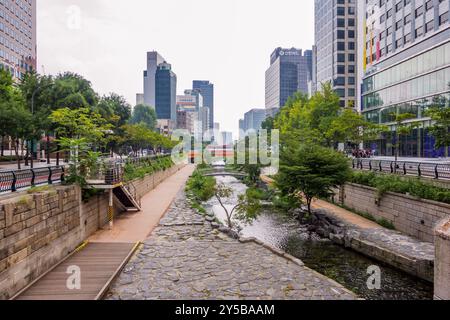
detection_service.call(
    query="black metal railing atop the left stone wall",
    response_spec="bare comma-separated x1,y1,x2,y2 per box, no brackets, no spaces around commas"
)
0,166,64,193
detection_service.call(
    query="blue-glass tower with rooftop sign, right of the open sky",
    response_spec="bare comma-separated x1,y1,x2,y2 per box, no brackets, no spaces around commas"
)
265,48,312,114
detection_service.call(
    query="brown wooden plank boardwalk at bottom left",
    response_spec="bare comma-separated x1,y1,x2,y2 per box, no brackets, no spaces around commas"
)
13,243,138,300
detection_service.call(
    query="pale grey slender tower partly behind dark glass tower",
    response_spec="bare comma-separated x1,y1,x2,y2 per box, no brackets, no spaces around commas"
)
136,51,165,107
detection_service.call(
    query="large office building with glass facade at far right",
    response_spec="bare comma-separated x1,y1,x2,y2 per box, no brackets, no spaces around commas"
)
362,0,450,158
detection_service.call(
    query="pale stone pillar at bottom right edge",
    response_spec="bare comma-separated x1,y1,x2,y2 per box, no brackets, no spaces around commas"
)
434,218,450,300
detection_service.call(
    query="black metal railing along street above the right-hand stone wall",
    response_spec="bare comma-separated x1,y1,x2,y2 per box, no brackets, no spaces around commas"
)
352,159,450,180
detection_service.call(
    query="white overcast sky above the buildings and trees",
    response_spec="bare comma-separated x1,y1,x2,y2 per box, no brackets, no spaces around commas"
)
37,0,314,134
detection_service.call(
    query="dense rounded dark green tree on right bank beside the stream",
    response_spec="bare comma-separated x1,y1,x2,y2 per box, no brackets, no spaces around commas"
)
275,144,351,213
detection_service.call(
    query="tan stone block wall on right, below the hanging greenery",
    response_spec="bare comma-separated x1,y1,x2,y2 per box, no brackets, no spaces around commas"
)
334,184,450,242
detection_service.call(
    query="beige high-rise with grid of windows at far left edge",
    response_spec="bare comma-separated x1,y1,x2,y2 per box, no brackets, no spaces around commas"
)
0,1,36,80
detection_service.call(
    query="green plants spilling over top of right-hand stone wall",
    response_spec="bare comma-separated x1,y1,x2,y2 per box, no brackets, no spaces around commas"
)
350,171,450,204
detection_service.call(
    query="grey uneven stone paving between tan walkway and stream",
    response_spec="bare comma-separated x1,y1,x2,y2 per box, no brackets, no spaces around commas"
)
107,192,356,300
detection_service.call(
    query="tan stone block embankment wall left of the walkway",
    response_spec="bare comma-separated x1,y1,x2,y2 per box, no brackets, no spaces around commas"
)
0,166,181,300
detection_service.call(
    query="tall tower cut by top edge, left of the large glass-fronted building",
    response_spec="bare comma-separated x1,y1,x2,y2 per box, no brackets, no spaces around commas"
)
314,0,358,107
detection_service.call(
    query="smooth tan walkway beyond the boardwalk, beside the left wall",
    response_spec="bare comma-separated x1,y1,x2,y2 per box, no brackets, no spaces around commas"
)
88,165,195,243
